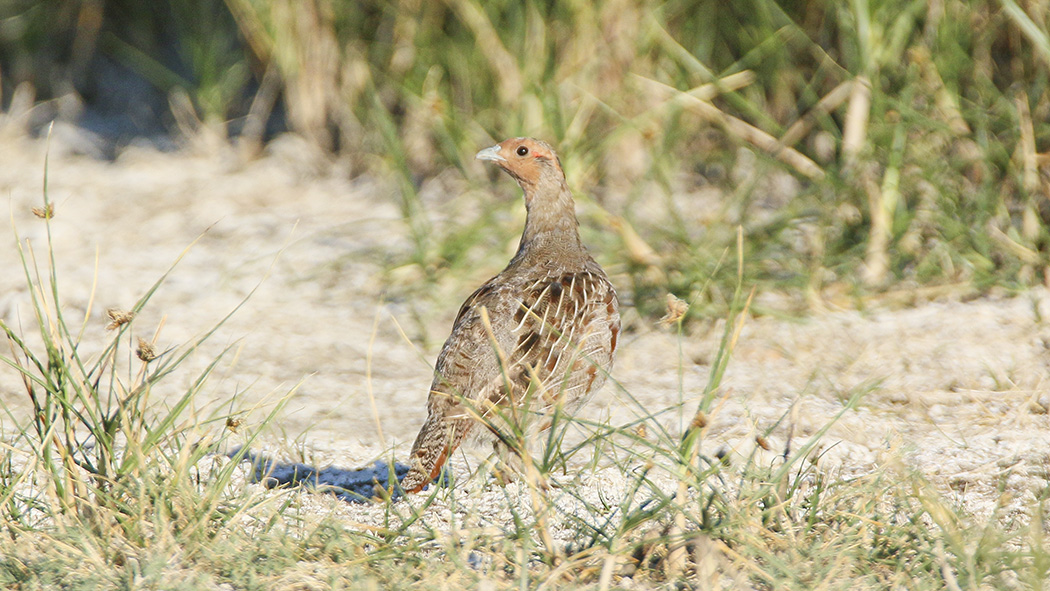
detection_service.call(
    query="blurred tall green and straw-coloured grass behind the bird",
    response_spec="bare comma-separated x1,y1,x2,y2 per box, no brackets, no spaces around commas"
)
0,0,1050,315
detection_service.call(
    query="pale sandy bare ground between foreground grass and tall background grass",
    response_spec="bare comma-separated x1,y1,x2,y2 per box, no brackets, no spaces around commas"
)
0,131,1050,533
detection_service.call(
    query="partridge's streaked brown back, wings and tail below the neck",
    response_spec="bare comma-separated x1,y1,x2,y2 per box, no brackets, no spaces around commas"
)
401,266,620,492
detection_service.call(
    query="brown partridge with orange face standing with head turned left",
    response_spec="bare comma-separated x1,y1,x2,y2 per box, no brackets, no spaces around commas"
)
400,138,621,492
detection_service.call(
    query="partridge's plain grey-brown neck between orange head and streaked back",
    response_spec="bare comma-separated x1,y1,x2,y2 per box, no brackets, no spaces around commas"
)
518,180,586,257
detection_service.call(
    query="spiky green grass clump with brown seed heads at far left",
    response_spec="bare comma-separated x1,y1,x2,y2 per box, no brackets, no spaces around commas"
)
0,146,282,587
